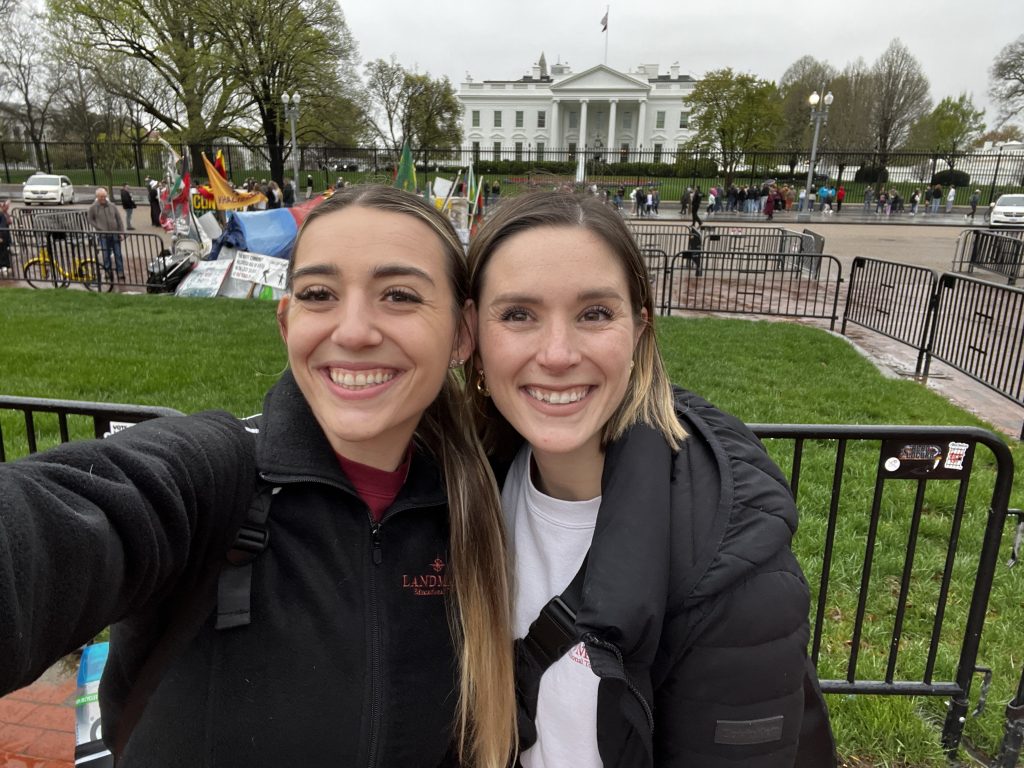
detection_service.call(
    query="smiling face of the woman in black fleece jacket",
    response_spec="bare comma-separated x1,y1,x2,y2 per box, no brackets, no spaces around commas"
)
278,206,472,470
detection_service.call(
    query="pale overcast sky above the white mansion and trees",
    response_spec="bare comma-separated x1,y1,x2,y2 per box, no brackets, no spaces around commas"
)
340,0,1024,122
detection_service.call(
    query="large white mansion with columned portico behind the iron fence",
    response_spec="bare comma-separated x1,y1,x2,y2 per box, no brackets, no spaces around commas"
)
458,53,696,162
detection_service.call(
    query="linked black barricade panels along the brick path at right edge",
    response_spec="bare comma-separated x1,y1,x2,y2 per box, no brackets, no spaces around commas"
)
842,257,1024,439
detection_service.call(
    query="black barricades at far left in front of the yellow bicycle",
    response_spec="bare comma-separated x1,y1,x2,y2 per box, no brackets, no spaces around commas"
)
10,227,166,291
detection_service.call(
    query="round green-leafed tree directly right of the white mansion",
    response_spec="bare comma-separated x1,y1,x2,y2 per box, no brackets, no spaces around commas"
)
683,68,783,185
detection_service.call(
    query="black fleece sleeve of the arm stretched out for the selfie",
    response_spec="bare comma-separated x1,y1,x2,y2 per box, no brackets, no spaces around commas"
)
0,413,256,694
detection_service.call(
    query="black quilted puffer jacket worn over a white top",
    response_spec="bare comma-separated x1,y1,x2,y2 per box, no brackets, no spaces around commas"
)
517,390,836,768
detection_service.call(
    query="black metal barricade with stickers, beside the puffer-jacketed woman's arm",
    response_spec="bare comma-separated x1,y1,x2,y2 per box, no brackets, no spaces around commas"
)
751,424,1024,768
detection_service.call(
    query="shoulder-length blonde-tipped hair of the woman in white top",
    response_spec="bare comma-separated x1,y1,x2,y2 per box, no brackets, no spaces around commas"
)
465,193,686,459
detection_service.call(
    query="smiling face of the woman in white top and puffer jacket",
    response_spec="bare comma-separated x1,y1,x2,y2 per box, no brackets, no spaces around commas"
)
476,226,646,484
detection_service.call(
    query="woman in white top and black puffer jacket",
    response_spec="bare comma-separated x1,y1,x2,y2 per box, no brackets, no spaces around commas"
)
465,194,835,768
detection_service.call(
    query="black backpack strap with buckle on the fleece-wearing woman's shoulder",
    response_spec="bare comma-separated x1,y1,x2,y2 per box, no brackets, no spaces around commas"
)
217,479,281,630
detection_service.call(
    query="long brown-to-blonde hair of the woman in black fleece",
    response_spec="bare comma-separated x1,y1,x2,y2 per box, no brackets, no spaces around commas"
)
288,185,516,768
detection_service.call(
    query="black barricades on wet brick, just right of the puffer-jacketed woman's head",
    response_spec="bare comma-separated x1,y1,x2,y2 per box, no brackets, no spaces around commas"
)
630,221,843,328
